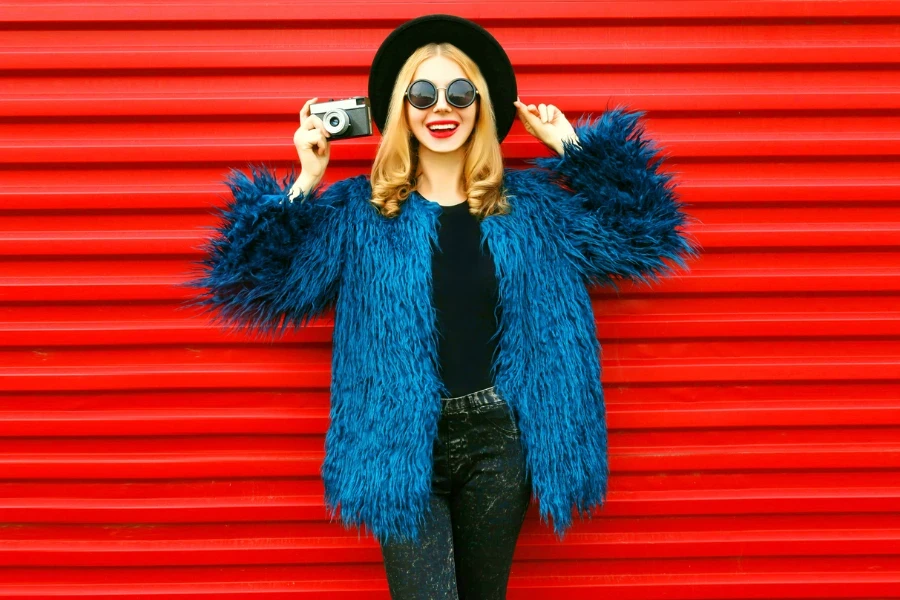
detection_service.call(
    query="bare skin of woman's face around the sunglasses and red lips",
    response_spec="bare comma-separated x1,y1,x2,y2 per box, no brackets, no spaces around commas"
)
403,56,481,153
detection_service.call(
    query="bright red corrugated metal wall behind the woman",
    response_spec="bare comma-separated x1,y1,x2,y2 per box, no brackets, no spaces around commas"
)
0,0,900,600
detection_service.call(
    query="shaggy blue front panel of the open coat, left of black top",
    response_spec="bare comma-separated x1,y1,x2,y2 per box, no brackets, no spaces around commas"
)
322,188,442,539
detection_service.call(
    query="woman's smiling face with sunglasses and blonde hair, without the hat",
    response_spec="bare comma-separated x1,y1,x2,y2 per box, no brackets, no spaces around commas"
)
371,42,515,218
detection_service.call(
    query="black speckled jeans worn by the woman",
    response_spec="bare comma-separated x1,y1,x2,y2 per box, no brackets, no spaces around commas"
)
381,387,531,600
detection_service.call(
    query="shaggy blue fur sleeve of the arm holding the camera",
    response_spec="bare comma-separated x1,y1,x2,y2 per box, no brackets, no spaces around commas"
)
185,164,348,337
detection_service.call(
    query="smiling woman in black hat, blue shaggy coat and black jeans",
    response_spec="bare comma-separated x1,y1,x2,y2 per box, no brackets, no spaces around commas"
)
189,15,698,598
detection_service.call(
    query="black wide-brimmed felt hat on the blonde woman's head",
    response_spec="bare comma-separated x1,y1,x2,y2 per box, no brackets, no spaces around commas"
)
369,14,518,142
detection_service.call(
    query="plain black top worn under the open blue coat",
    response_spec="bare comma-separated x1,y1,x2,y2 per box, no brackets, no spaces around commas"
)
432,202,500,397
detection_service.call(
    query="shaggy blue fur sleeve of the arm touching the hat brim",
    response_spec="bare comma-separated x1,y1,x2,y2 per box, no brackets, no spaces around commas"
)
533,108,699,287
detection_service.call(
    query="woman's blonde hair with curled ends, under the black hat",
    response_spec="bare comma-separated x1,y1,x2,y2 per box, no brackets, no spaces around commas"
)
370,43,509,219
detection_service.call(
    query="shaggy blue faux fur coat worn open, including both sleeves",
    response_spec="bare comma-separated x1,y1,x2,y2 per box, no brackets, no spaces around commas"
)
186,108,699,541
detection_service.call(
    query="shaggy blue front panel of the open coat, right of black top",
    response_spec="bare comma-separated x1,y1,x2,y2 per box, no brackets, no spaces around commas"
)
483,171,608,537
